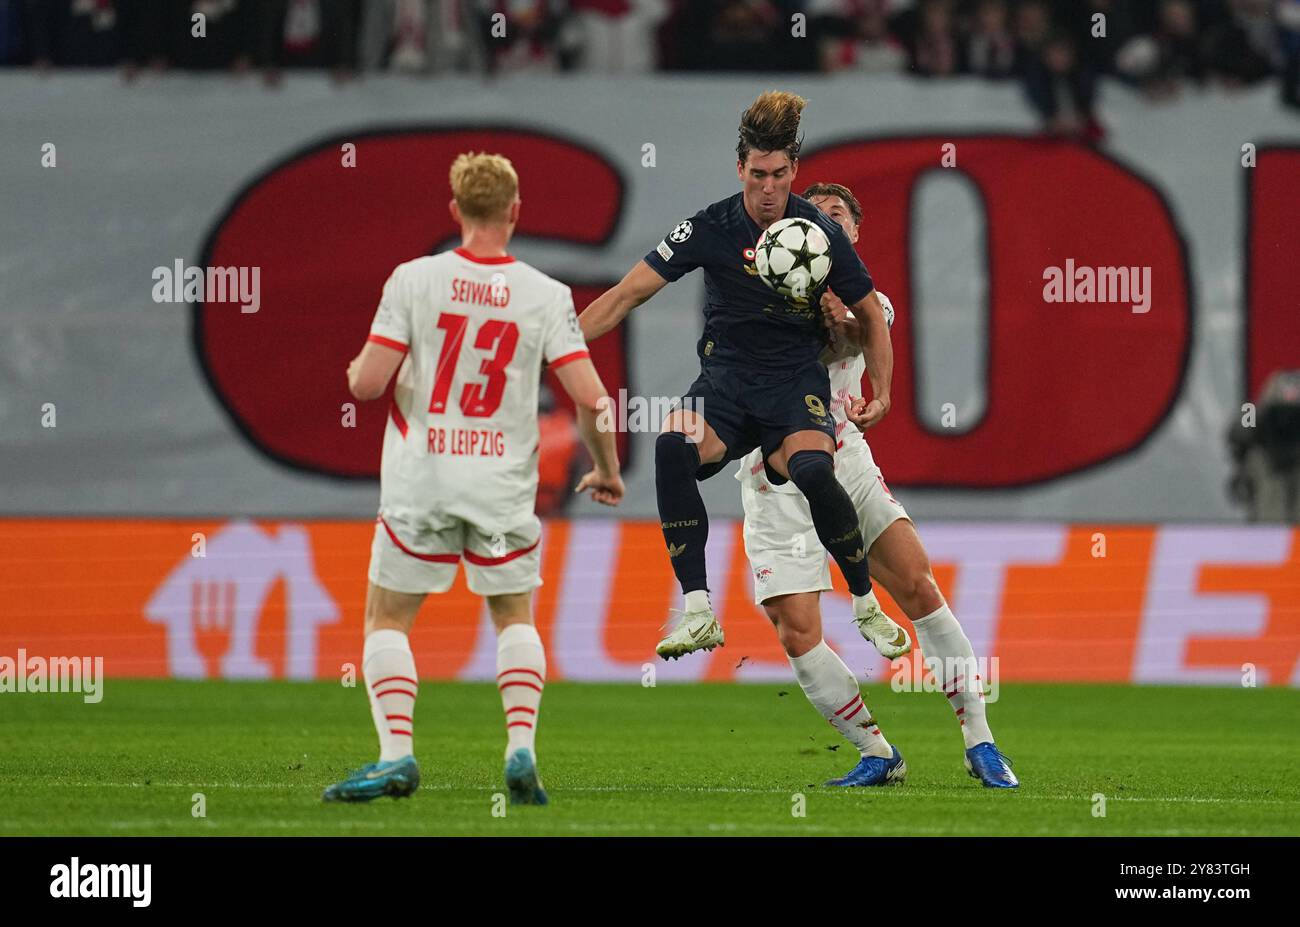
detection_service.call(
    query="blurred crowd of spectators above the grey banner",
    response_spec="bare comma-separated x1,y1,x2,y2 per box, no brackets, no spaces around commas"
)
0,0,1300,130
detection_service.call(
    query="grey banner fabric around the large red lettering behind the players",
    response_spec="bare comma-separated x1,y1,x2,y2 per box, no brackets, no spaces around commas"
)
0,73,1300,521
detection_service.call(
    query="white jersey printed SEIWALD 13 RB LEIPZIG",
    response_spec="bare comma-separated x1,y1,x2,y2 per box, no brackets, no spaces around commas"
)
371,248,588,542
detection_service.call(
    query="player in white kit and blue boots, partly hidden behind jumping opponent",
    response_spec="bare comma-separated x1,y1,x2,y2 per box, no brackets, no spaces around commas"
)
736,183,1019,788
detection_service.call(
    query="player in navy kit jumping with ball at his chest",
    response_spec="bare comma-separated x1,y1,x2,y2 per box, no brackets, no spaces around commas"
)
579,91,910,659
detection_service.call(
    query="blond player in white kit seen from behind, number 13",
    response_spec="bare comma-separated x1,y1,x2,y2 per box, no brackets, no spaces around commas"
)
322,153,623,805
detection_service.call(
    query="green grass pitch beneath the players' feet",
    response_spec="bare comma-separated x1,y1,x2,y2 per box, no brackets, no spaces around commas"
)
0,679,1300,836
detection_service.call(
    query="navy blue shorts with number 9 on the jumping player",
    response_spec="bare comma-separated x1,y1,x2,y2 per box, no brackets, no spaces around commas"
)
683,360,835,482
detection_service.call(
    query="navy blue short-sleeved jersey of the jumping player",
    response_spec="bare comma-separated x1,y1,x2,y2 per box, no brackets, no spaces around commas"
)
645,192,875,371
